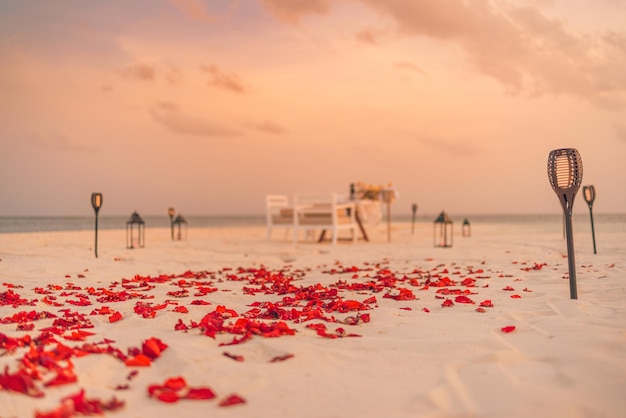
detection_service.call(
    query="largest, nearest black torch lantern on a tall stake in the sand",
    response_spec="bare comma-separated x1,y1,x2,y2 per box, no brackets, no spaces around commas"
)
548,148,583,299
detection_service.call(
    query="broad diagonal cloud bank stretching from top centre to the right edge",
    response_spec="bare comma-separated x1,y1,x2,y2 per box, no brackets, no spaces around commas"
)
262,0,626,109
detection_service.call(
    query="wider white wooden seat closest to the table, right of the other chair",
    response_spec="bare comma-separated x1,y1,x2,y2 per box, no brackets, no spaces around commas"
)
293,193,358,244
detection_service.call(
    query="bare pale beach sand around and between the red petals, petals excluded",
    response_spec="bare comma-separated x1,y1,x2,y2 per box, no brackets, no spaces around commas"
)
0,220,626,418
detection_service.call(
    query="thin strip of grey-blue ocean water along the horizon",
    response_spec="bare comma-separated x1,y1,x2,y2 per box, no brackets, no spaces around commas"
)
0,213,626,234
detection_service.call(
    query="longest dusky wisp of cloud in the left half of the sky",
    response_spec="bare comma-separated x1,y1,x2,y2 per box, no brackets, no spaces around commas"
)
150,102,242,137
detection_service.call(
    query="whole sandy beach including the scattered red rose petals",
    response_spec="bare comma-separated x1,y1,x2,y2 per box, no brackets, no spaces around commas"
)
0,219,626,418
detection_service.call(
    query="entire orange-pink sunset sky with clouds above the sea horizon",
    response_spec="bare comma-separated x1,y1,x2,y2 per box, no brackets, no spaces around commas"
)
0,0,626,216
